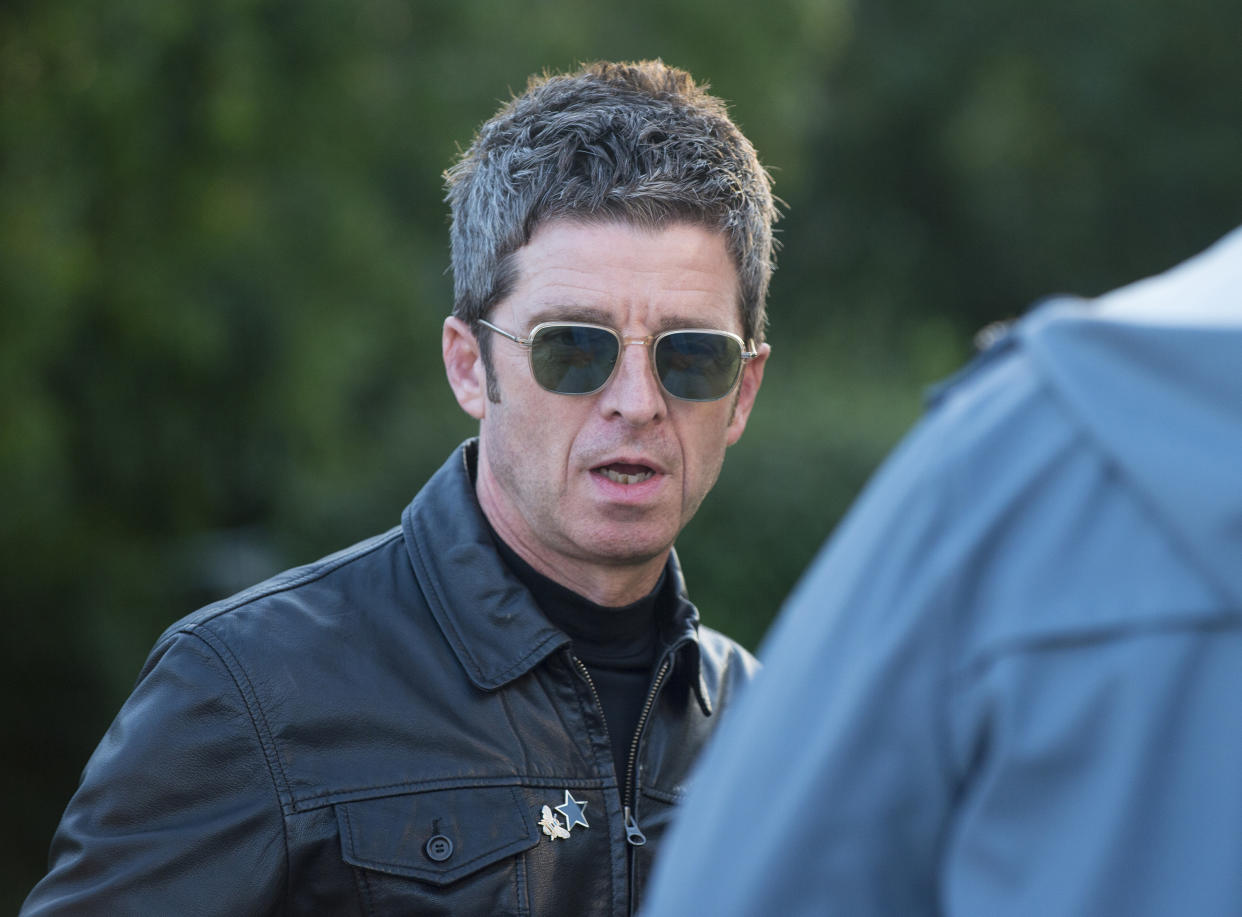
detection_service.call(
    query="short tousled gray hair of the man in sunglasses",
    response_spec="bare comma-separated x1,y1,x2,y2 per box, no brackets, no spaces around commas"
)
445,60,777,347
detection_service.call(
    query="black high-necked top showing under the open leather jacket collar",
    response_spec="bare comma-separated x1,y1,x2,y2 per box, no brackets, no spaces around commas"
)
492,531,667,792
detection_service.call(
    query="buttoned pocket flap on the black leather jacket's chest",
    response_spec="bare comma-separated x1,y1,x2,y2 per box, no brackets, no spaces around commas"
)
337,787,539,885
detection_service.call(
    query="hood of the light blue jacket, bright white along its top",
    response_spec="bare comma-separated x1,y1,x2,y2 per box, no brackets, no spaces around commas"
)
1015,222,1242,608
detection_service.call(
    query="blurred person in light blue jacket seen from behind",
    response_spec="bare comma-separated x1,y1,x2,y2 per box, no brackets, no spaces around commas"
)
645,224,1242,917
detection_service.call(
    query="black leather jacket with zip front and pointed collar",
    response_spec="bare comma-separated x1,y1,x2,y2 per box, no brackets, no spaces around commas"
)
22,442,756,917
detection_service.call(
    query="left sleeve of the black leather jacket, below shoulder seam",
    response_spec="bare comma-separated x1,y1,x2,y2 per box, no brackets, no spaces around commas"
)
21,634,286,917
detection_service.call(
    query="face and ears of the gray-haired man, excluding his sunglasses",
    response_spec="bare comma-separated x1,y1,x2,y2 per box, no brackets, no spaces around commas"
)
445,220,768,604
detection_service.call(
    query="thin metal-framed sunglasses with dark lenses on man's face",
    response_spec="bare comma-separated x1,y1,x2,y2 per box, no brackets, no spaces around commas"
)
479,318,759,401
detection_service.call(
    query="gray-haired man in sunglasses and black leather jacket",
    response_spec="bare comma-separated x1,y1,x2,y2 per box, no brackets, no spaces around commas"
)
25,61,775,917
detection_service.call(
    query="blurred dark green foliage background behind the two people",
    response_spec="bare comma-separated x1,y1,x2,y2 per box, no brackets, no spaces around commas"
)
0,0,1242,911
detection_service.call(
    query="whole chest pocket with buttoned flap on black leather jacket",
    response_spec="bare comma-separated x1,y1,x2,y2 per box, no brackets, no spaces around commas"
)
337,787,539,917
